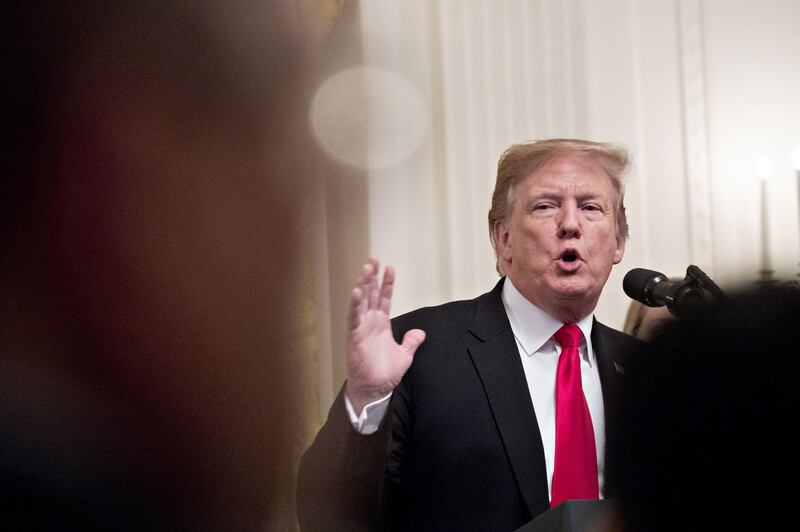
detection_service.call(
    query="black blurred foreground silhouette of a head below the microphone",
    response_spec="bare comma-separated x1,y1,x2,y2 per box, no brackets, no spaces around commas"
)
606,287,800,531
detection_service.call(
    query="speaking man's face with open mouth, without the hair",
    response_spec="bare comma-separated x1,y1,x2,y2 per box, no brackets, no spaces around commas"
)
494,156,625,321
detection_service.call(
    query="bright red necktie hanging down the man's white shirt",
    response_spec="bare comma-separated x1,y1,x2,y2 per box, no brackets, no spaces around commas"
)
550,323,599,508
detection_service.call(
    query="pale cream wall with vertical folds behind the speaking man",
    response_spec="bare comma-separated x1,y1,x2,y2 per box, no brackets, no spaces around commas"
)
310,0,800,408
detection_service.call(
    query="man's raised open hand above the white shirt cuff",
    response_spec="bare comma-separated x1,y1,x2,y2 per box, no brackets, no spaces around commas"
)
345,258,425,414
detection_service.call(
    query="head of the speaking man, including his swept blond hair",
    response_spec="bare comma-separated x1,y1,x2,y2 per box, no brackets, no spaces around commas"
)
489,140,627,322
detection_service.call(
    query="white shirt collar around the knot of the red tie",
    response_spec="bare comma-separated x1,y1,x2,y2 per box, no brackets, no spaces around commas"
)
500,277,594,365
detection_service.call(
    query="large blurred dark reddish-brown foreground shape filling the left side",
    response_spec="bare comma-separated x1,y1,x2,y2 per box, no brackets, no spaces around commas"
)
0,0,309,529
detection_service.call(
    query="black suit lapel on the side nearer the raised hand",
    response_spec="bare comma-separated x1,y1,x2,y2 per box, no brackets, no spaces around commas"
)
469,280,549,515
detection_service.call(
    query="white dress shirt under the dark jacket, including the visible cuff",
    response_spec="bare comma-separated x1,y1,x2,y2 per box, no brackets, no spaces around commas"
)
344,277,605,497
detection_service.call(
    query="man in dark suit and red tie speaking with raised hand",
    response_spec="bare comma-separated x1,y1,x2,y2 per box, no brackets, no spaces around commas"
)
298,139,635,530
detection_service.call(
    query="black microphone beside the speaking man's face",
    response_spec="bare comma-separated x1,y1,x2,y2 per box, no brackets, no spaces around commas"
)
622,268,706,316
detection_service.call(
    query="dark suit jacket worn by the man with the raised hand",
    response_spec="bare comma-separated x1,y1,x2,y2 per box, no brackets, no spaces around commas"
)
298,280,638,531
